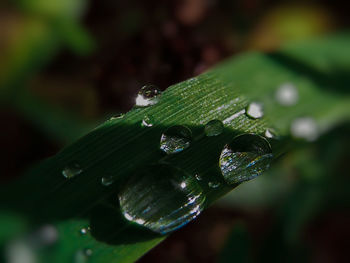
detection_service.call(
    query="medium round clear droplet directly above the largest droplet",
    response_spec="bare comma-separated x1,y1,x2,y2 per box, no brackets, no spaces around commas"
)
160,125,192,154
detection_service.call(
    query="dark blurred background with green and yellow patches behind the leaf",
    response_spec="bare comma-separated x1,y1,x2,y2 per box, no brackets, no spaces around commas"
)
0,0,350,262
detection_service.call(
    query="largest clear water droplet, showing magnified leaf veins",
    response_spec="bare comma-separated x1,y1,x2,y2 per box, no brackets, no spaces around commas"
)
118,164,205,234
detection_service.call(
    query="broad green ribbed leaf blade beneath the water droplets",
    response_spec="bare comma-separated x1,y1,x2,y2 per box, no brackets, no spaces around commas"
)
0,35,350,262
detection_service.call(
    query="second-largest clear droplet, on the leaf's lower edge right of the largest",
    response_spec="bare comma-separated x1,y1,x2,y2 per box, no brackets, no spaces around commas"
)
219,134,272,184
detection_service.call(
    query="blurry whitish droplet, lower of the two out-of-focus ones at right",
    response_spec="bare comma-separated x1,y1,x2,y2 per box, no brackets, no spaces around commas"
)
290,117,318,141
